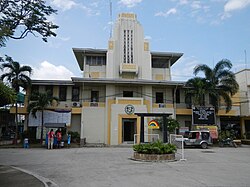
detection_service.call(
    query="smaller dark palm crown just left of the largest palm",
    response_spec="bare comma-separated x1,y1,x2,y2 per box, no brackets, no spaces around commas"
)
185,77,206,106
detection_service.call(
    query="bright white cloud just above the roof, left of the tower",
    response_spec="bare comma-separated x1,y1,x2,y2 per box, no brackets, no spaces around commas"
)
32,61,74,80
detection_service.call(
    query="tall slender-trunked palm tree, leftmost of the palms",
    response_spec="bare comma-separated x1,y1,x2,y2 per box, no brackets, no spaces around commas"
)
0,56,32,143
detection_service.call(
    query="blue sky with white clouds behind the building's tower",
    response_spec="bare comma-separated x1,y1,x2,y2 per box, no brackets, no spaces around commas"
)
0,0,250,81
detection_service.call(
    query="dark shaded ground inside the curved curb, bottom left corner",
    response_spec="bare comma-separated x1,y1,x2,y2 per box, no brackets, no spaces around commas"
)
0,165,44,187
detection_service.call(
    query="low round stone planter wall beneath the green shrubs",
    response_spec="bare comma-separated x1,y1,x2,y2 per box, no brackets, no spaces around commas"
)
134,152,175,161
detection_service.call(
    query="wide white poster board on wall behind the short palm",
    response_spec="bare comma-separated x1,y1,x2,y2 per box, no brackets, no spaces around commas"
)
29,110,71,127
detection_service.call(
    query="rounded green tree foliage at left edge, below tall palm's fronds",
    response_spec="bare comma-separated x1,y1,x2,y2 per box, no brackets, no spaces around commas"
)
0,82,16,107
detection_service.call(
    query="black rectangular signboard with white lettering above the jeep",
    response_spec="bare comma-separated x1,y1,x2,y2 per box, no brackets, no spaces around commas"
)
192,107,215,125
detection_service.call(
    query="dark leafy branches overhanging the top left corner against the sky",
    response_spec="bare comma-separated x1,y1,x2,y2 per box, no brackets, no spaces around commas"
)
0,0,58,47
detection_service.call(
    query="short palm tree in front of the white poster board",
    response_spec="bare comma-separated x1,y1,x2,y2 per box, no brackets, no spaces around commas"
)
27,92,58,143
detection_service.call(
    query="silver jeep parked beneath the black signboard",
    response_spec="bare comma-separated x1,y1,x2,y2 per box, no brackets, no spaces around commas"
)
184,130,213,149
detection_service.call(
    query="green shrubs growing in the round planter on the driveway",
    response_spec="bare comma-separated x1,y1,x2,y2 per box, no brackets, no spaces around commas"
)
133,141,176,154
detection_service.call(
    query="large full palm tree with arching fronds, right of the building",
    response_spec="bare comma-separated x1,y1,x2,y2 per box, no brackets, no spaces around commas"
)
191,59,239,112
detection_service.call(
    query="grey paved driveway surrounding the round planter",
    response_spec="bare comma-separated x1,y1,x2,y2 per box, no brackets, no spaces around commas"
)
0,146,250,187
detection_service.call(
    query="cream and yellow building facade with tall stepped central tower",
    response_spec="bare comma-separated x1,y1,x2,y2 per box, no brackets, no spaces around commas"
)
22,13,240,145
